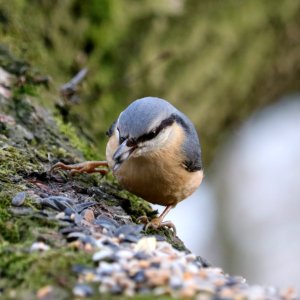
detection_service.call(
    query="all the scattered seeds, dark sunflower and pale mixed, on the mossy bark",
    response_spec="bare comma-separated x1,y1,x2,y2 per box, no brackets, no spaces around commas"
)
12,189,296,300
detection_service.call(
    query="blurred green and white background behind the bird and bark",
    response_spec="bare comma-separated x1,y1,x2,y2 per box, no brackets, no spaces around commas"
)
0,0,300,290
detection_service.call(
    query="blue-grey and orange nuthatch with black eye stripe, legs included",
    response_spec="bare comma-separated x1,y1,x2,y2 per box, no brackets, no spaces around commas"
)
51,97,204,234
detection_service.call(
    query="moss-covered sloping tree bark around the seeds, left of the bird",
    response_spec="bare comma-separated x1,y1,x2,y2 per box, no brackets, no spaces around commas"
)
0,48,185,299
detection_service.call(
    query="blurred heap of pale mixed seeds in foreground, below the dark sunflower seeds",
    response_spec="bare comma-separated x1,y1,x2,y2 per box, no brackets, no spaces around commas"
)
69,225,296,300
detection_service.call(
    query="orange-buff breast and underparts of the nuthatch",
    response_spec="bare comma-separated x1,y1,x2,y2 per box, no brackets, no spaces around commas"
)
106,122,203,206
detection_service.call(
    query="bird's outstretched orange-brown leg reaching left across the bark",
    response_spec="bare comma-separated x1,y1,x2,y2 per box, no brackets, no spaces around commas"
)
50,161,108,175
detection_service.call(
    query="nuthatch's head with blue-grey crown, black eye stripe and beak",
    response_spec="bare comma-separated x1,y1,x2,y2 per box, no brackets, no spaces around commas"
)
112,97,185,171
